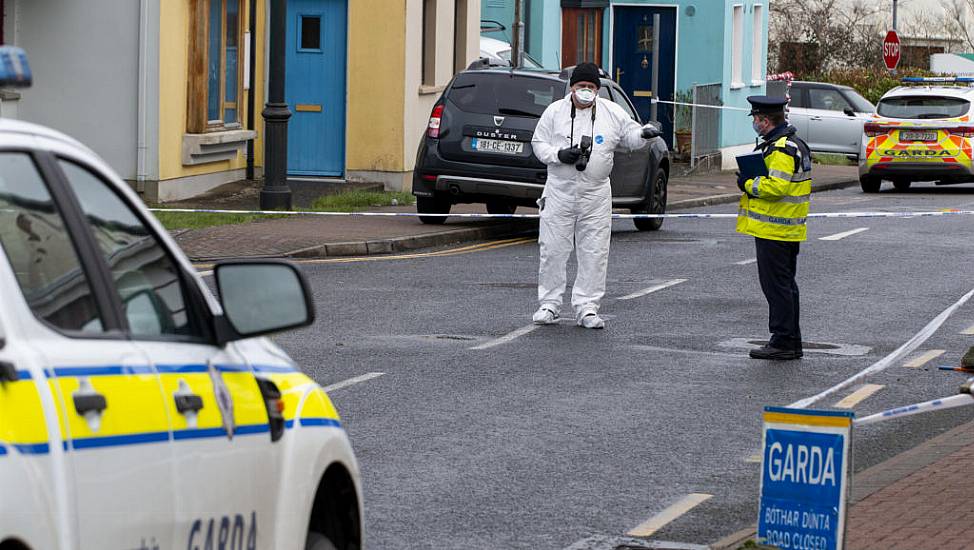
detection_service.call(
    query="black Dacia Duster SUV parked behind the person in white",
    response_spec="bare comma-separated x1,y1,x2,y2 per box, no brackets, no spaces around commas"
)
413,63,670,231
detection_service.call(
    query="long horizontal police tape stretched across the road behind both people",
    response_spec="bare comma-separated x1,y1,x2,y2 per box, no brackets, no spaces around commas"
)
149,208,974,220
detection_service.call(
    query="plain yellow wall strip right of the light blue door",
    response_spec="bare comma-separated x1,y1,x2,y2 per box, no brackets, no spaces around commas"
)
345,0,406,172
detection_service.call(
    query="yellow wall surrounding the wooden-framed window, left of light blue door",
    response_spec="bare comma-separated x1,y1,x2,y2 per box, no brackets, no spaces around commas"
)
159,0,265,180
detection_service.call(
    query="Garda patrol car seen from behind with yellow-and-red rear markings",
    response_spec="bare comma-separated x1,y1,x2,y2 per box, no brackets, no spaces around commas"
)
859,77,974,193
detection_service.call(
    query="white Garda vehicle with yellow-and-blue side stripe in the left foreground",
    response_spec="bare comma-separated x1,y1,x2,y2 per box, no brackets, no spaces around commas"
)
0,47,363,550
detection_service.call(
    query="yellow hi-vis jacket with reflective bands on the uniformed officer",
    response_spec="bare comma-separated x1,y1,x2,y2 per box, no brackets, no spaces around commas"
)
737,132,812,241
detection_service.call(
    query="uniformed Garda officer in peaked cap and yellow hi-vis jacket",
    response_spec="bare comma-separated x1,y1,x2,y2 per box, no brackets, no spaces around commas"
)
737,96,812,360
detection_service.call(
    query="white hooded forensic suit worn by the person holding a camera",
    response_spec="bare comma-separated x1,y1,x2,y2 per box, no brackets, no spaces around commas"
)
531,94,649,320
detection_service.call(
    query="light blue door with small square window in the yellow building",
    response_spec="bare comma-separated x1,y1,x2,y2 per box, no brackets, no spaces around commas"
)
286,0,347,176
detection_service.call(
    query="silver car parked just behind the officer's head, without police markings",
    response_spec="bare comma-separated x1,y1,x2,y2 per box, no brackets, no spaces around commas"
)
788,82,876,157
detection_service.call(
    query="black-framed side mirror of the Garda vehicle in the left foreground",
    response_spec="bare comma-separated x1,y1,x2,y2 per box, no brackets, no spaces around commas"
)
213,260,315,344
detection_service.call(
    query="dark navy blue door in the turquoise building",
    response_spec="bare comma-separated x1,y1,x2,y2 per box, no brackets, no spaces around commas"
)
612,6,676,149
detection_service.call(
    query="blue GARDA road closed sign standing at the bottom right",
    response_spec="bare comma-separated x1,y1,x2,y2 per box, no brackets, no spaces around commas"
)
758,407,853,550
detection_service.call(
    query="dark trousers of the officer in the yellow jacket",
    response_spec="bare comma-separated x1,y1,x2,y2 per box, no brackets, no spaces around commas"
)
754,237,802,350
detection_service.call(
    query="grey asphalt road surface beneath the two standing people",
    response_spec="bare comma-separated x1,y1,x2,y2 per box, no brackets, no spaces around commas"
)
277,185,974,550
